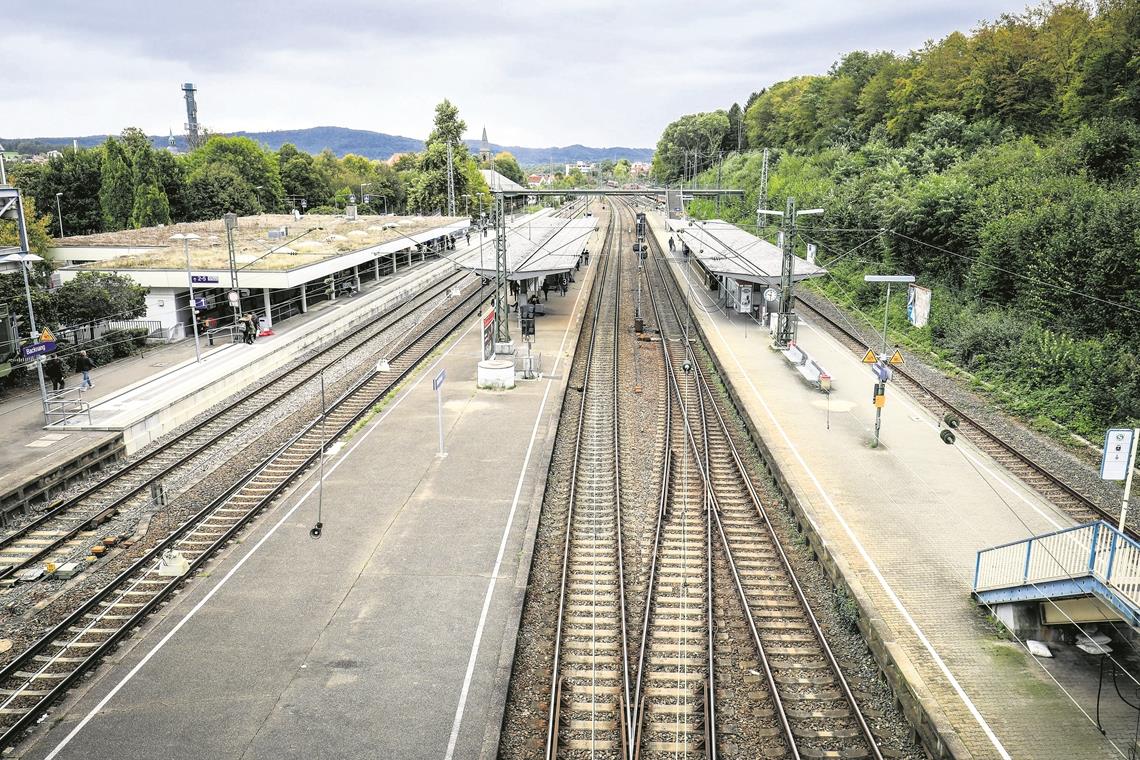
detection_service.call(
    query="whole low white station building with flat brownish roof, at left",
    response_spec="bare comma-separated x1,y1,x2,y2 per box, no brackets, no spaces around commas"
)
48,213,470,340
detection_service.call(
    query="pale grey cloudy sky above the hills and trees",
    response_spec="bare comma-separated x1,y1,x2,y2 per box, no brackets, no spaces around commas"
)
0,0,1025,147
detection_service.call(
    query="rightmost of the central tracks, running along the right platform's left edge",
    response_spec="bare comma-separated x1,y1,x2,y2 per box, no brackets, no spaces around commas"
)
650,219,882,760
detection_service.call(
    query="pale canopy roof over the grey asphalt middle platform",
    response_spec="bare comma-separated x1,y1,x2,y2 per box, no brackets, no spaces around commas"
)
465,216,597,280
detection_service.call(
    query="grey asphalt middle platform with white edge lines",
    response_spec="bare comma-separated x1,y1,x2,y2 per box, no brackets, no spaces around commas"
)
19,216,594,760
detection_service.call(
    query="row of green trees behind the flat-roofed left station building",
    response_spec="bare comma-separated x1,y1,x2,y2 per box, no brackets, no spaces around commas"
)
8,100,526,235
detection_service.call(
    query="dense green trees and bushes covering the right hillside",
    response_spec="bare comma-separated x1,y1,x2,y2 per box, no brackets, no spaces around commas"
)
654,0,1140,436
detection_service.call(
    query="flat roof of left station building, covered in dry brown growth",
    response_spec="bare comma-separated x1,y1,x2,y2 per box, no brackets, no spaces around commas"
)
54,214,469,271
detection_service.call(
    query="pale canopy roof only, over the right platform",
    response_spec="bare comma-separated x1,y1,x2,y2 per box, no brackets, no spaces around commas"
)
666,219,828,286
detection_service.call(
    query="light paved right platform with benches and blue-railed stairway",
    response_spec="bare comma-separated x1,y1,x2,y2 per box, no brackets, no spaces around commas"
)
651,214,1135,760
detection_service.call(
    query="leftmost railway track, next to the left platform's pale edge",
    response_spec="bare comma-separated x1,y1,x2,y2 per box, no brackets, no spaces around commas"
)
0,267,471,582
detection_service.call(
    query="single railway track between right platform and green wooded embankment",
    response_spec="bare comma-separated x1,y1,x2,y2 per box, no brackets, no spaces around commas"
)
796,296,1121,540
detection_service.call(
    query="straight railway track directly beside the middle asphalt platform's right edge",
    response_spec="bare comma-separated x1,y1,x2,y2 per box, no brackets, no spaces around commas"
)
545,209,630,760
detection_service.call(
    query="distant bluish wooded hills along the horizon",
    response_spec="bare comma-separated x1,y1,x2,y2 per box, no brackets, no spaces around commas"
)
0,126,653,166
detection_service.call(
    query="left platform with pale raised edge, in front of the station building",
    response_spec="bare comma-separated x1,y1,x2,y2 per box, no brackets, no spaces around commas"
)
0,210,556,518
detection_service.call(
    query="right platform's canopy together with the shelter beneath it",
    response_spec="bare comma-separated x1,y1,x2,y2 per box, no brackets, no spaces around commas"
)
666,218,828,324
